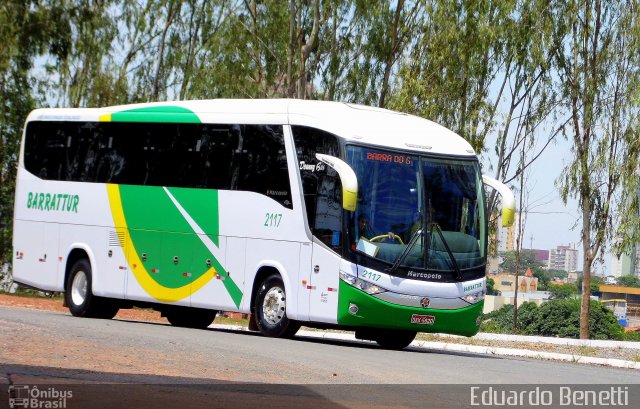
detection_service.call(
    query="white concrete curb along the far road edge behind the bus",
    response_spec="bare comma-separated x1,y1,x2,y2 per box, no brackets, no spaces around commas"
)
210,324,640,369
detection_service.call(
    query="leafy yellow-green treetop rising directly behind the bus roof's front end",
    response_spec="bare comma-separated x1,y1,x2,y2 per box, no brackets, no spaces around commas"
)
389,0,515,152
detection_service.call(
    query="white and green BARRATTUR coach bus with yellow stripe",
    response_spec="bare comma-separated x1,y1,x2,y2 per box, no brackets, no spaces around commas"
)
13,99,514,348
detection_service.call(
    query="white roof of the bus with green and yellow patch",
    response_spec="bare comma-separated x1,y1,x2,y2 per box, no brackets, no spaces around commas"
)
27,99,475,156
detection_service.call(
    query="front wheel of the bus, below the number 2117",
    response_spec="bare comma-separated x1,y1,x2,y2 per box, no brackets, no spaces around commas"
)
254,274,300,338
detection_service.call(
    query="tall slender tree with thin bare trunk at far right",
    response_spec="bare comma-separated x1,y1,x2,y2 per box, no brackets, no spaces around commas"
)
555,0,640,339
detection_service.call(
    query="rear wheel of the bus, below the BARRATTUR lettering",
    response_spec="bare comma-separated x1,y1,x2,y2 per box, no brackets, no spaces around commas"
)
64,259,119,319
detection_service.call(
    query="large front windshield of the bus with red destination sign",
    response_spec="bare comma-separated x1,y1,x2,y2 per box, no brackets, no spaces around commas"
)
347,146,486,278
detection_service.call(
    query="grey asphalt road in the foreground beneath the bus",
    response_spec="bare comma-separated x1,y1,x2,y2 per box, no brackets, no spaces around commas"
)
0,307,640,408
